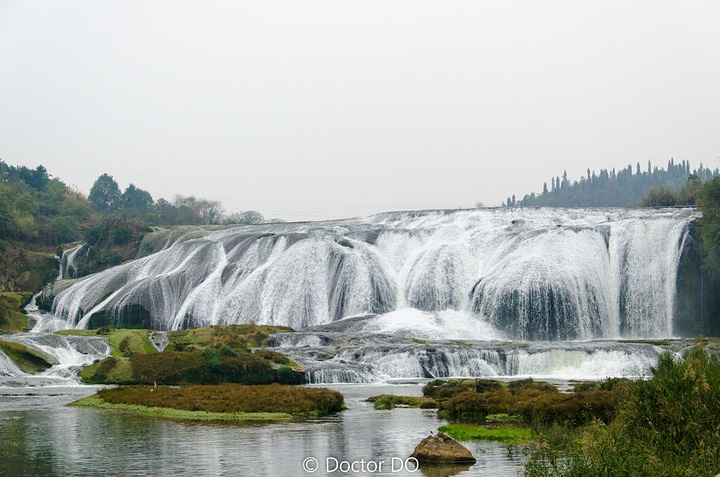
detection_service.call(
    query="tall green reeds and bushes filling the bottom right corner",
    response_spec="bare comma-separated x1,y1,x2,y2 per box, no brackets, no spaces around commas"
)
525,346,720,477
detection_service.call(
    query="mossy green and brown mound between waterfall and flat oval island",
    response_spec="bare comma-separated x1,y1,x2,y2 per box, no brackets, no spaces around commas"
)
59,324,304,385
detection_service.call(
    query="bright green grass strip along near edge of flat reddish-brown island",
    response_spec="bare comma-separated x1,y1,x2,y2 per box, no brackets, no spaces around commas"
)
68,395,293,421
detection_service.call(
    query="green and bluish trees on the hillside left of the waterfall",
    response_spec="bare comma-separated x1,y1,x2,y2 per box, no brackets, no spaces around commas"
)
0,160,274,247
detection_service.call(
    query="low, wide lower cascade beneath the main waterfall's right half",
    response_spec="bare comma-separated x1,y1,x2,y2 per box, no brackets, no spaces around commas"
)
272,333,663,384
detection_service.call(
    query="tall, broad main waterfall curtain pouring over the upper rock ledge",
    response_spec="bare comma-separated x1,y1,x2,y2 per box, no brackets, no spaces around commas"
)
46,209,699,340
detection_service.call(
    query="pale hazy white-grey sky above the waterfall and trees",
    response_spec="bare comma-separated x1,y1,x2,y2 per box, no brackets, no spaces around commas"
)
0,0,720,220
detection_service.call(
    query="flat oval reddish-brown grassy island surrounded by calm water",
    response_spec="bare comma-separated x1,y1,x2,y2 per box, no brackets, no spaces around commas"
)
70,384,345,421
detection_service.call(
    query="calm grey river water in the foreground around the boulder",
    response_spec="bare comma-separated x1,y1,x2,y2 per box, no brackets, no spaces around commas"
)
0,384,526,477
